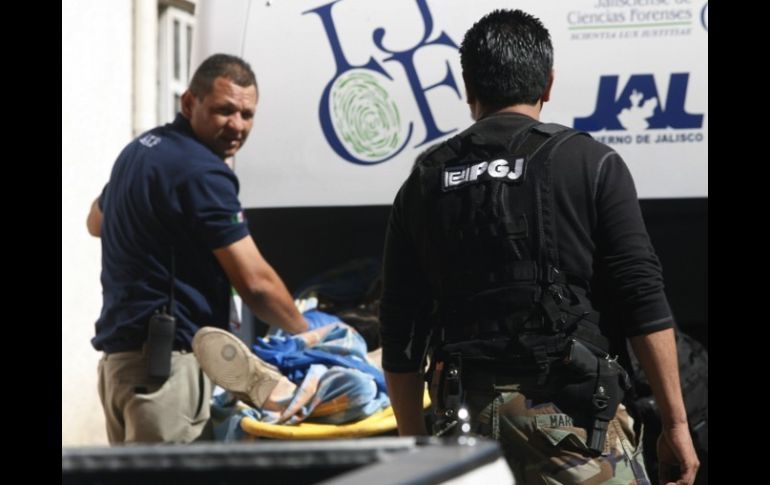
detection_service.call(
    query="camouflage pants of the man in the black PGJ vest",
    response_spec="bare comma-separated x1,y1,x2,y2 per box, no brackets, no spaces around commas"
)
465,389,650,485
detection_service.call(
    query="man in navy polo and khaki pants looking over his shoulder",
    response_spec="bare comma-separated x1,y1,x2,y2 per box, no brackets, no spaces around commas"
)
87,54,308,444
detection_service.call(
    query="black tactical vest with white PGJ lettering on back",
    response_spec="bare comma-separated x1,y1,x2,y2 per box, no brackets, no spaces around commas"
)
418,122,607,360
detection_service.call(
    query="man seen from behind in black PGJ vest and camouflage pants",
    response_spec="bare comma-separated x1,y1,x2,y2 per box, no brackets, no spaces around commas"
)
380,10,699,484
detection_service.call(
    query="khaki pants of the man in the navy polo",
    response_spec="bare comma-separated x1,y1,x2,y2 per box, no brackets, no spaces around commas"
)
99,352,213,444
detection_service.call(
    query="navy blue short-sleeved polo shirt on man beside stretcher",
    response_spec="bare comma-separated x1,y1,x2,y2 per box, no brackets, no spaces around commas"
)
91,115,248,353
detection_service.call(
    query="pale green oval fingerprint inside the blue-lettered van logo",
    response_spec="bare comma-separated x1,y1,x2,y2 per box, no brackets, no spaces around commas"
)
330,69,401,162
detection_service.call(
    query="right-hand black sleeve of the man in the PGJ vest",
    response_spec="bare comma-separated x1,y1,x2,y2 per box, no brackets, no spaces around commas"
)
596,153,674,337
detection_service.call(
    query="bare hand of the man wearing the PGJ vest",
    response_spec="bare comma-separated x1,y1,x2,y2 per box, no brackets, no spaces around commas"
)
658,424,700,485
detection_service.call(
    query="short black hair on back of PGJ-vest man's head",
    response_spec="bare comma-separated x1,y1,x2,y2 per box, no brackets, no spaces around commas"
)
460,10,553,108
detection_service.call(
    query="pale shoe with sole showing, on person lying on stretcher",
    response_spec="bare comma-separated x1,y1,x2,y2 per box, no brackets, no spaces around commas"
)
192,327,283,408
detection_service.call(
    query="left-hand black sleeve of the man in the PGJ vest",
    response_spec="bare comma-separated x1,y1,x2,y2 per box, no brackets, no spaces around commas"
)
380,171,430,372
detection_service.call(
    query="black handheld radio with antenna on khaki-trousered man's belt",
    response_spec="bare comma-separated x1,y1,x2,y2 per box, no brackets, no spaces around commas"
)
144,248,176,380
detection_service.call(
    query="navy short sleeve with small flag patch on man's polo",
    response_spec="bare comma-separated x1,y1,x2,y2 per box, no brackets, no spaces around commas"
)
178,164,249,250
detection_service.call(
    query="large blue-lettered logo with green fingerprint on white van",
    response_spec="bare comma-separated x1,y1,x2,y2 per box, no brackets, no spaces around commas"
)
303,0,462,165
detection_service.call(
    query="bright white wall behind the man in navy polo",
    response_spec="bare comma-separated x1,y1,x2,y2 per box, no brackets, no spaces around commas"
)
62,0,132,446
